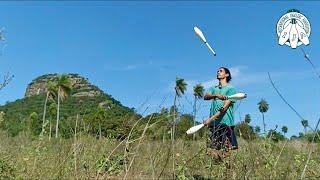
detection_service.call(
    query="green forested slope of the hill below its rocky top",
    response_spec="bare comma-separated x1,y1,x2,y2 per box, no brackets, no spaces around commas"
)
0,95,139,138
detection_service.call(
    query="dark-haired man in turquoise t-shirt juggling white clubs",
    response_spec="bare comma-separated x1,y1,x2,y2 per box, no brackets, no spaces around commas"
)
204,67,238,157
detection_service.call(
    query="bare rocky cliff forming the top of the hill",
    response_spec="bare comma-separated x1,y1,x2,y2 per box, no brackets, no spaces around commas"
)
25,74,103,97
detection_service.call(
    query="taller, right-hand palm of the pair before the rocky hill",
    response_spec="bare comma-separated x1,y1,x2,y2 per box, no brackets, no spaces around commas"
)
56,75,72,138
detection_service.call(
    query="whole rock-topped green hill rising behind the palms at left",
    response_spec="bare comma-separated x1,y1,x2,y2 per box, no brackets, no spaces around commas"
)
0,74,140,138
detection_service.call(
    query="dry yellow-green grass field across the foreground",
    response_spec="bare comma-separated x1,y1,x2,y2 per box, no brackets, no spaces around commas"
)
0,132,320,179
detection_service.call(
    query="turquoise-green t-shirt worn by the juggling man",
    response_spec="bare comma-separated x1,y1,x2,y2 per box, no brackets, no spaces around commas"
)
207,84,236,126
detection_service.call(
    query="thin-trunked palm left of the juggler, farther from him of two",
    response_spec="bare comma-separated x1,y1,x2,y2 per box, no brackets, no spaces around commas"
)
171,78,187,178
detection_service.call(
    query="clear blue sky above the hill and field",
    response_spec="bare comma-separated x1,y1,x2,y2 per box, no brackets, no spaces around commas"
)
0,1,320,136
